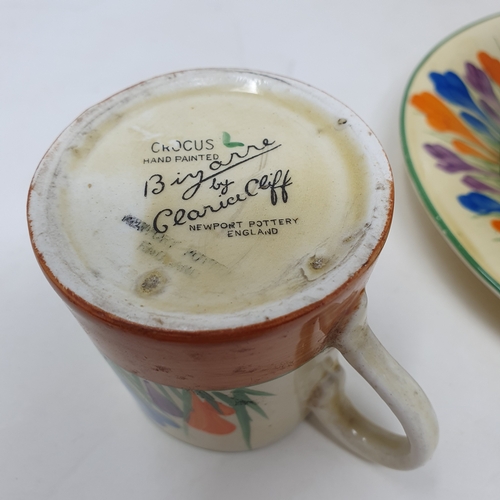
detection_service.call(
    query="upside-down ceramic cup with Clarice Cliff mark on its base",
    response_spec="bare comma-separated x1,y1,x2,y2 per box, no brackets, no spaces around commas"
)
28,70,437,469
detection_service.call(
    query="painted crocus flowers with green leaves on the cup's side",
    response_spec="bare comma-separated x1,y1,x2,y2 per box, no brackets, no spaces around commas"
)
108,360,273,449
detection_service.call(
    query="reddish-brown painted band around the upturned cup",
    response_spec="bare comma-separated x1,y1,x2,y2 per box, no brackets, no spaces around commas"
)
29,221,385,390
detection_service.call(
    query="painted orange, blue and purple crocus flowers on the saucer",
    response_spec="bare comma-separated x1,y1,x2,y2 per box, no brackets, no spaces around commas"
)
411,51,500,232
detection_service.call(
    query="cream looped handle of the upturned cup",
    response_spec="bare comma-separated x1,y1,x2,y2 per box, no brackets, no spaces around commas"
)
309,293,438,470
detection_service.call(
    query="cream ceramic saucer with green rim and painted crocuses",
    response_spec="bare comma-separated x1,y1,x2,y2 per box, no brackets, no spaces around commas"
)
401,15,500,295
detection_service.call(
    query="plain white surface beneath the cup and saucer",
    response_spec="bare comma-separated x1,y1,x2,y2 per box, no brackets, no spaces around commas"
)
0,0,500,500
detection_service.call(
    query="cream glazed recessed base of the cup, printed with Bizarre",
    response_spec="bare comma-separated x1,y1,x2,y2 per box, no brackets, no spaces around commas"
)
49,86,371,313
